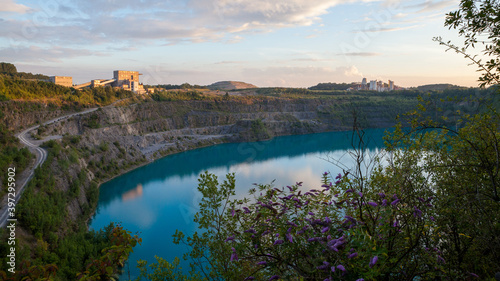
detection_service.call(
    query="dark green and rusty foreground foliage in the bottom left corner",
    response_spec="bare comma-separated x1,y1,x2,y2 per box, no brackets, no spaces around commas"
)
0,223,141,281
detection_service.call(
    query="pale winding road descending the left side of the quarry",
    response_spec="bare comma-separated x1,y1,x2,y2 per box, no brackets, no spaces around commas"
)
0,106,99,227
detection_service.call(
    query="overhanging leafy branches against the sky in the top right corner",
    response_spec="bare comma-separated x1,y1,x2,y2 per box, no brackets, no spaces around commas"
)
434,0,500,87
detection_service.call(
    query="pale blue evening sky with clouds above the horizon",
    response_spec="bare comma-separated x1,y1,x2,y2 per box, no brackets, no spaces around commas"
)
0,0,479,87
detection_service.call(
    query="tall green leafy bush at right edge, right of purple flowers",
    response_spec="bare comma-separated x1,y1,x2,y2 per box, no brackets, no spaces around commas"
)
394,97,500,280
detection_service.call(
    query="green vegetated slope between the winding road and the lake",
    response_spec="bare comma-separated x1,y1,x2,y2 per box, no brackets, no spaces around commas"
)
0,137,140,280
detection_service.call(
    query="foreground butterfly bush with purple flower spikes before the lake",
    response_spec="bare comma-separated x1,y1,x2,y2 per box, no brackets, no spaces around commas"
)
161,166,450,280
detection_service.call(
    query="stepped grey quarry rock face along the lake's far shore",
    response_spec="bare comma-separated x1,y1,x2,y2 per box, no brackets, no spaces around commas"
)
39,99,400,162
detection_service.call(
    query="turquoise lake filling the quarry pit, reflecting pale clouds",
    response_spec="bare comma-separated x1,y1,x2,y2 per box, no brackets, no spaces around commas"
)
90,129,390,280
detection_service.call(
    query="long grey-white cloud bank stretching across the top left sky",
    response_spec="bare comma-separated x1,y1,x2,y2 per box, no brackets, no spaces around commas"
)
0,0,352,45
